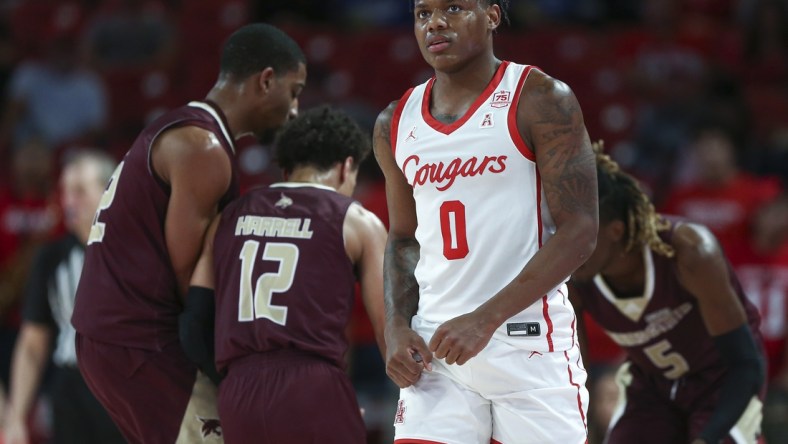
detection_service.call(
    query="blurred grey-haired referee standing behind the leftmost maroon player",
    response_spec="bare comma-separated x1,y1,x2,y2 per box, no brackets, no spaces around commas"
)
3,151,124,444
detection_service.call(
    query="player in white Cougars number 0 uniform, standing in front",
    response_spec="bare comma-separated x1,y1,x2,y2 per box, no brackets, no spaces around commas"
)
374,0,598,444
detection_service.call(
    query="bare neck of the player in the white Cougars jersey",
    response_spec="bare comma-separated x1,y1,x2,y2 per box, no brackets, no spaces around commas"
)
430,53,501,115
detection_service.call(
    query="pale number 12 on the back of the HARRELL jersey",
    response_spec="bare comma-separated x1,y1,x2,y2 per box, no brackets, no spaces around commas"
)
238,240,299,325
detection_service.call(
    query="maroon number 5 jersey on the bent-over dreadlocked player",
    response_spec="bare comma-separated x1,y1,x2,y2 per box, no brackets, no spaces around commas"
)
573,220,760,379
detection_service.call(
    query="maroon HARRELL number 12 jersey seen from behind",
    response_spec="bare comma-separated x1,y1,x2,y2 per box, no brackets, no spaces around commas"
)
214,183,356,370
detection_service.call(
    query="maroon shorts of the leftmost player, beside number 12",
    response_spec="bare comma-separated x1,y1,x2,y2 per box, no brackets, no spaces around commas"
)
76,333,203,444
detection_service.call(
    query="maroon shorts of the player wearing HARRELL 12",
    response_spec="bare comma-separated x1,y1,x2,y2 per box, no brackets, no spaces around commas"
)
219,350,366,444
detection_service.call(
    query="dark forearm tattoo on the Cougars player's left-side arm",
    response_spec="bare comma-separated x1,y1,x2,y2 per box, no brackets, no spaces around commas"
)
383,238,420,321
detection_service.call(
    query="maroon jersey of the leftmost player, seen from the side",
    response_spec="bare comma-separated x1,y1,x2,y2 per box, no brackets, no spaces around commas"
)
72,102,239,350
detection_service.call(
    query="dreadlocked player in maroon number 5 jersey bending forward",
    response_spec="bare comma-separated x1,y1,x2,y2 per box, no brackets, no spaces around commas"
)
570,144,764,444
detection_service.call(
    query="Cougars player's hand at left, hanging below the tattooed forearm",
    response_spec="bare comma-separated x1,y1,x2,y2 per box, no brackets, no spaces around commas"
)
386,326,432,388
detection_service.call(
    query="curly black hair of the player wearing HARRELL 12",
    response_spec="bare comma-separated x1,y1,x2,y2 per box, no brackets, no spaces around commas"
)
275,105,371,174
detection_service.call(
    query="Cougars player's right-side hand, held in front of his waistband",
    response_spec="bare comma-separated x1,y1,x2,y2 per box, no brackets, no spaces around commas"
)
430,311,495,365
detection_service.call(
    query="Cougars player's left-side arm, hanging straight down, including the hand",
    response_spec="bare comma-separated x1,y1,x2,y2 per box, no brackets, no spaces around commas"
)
372,102,432,387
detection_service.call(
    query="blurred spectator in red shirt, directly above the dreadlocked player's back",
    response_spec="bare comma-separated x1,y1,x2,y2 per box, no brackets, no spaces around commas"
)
661,127,780,251
